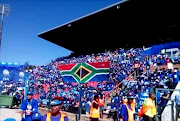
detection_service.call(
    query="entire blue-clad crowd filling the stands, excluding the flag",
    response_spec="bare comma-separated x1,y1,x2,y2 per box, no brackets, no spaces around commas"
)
0,48,179,120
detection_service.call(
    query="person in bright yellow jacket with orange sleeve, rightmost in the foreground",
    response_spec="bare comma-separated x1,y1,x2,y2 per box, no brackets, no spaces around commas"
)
138,92,157,121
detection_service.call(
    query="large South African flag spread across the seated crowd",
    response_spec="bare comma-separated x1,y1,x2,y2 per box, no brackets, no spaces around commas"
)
59,62,109,83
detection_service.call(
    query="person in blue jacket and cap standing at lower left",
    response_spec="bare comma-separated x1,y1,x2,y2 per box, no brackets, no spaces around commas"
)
18,92,38,121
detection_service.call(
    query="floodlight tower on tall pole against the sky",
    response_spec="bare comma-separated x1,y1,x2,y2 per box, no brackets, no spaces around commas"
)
0,4,10,61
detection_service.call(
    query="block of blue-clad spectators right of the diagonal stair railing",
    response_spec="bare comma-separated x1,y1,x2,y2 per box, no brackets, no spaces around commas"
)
108,54,180,120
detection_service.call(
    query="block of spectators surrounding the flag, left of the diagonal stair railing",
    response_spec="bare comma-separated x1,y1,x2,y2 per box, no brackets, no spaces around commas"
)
26,49,142,110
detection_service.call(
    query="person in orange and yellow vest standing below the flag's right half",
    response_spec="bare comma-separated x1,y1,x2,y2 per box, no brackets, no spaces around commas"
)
90,95,103,121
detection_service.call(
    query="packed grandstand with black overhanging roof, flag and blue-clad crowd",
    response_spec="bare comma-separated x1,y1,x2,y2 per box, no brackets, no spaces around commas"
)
0,0,180,121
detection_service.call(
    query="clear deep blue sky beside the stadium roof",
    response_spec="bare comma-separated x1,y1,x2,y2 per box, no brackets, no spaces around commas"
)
0,0,119,65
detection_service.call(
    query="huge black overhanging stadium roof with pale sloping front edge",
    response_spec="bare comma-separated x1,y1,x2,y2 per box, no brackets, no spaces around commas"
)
38,0,180,54
